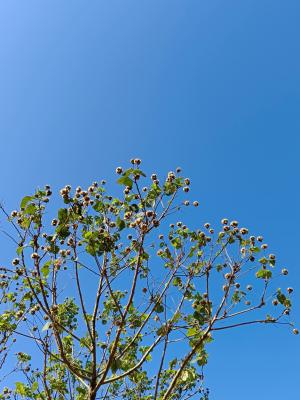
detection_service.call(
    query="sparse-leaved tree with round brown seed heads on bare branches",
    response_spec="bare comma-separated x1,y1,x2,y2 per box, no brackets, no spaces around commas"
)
0,159,298,400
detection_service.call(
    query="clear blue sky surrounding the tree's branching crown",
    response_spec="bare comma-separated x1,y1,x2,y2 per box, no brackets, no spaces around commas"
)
0,0,300,400
